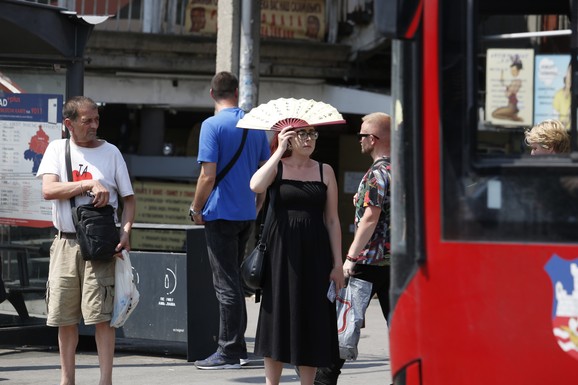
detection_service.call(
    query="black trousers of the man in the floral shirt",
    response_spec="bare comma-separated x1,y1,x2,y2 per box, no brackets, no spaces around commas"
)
314,265,390,385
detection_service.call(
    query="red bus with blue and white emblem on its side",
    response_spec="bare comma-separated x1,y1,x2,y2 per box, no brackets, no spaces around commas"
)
375,0,578,385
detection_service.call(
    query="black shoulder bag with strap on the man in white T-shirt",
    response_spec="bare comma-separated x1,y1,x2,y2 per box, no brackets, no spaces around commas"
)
66,139,120,261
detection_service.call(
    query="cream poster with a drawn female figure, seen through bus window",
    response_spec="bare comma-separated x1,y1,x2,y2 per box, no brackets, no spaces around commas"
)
486,48,534,126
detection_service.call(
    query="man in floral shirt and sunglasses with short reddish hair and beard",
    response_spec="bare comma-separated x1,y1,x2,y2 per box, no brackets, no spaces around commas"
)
315,112,391,385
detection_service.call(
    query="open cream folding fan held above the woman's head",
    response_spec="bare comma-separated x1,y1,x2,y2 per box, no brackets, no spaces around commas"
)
237,98,345,131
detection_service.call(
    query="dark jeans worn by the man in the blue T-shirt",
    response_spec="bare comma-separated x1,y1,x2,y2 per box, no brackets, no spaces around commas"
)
205,220,254,359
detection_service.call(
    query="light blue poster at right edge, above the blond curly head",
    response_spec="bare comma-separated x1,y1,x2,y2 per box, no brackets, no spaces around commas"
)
534,55,572,129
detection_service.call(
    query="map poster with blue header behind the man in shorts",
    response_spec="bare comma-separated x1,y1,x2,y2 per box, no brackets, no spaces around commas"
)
0,94,63,227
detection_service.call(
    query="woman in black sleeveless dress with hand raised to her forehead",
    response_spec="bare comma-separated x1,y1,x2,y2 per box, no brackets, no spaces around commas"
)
251,127,344,385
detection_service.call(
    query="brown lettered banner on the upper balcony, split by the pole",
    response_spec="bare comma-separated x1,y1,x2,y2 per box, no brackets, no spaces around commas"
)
185,0,325,40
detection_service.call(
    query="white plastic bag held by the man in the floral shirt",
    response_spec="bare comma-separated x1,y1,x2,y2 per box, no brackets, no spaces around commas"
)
335,277,373,360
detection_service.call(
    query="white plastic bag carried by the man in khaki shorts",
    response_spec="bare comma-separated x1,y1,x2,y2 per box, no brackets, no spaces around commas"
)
110,250,140,328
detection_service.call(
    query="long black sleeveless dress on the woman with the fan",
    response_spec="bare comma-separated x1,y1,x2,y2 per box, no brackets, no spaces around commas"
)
255,162,339,367
